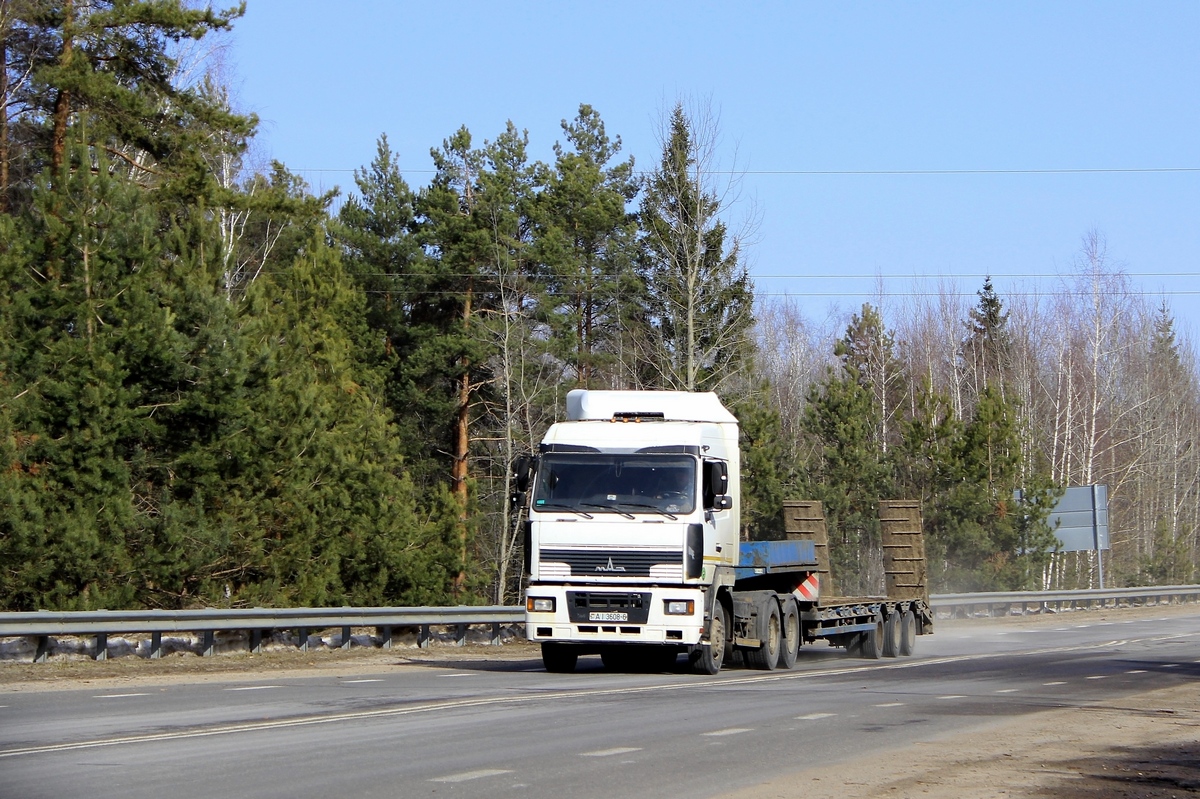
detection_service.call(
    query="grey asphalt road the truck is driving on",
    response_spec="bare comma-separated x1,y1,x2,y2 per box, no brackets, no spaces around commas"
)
0,611,1200,799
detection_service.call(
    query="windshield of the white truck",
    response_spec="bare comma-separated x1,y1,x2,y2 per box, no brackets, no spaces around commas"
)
533,452,696,516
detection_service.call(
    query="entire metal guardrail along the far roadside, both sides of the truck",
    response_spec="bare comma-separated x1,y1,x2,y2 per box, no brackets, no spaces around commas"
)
0,585,1200,662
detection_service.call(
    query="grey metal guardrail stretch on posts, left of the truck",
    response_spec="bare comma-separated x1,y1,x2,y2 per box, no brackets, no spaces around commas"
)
0,605,524,662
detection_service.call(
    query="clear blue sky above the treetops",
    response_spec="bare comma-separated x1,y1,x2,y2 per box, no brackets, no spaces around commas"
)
228,0,1200,338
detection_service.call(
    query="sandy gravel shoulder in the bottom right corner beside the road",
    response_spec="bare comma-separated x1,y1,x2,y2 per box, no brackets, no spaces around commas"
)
725,685,1200,799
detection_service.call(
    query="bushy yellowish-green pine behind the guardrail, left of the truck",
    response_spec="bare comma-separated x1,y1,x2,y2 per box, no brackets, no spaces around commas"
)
230,233,460,605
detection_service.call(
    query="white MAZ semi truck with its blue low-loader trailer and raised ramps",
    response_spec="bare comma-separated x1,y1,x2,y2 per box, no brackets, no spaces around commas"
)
514,390,932,674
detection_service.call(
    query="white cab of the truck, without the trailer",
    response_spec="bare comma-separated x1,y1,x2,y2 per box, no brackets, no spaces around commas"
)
518,390,739,671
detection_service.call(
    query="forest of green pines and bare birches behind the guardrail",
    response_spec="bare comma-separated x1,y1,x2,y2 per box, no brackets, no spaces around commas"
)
0,0,1200,611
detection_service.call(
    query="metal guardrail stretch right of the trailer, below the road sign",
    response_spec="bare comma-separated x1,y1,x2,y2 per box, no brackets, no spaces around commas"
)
929,585,1200,615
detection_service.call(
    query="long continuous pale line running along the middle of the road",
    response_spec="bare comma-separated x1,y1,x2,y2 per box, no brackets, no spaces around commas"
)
11,631,1200,759
